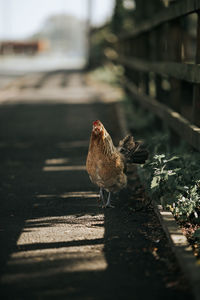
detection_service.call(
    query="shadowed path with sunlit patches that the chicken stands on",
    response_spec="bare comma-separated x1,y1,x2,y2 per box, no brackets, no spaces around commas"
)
0,72,192,300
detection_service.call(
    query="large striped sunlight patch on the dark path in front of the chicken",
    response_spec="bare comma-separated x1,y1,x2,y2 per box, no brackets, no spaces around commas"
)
1,211,107,285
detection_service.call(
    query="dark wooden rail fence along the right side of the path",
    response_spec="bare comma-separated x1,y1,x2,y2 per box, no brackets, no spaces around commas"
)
113,0,200,151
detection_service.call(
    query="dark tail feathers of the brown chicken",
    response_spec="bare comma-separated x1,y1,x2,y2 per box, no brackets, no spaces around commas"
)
118,135,148,164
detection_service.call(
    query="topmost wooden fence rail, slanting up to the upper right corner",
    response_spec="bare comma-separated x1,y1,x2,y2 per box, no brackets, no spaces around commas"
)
120,0,200,40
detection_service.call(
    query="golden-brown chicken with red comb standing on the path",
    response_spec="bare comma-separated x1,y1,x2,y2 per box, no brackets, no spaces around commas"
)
86,120,148,208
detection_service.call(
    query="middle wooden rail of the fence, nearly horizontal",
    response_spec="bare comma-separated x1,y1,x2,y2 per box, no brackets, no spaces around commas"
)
116,56,200,83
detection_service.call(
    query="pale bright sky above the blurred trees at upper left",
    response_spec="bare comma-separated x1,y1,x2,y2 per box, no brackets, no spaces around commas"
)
0,0,115,39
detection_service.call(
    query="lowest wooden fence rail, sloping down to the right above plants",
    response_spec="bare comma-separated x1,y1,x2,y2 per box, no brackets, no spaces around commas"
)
123,79,200,151
